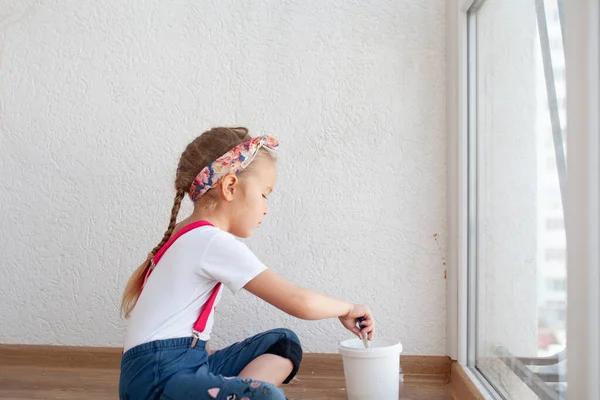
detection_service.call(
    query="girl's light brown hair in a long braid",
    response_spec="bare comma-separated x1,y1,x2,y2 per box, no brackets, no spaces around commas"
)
121,127,275,318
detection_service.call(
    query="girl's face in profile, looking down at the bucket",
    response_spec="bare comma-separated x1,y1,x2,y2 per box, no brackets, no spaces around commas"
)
230,159,277,238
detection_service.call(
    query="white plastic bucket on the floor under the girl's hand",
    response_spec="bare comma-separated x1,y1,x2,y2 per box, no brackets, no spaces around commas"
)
340,338,402,400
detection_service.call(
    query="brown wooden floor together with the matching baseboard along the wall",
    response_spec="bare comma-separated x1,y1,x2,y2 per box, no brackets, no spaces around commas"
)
0,345,458,400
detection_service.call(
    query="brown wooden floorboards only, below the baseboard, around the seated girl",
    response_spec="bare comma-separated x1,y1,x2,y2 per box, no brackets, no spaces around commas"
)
0,365,453,400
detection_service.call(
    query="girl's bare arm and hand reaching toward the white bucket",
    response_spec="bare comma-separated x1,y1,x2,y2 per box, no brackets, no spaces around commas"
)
244,269,374,339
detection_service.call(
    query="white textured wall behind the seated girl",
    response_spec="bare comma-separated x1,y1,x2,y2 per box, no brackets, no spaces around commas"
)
0,0,445,354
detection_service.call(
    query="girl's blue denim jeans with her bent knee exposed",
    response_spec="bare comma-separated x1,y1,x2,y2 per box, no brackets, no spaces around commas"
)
119,329,302,400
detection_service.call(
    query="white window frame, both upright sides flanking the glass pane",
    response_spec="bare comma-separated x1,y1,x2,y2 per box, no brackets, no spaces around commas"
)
446,0,600,399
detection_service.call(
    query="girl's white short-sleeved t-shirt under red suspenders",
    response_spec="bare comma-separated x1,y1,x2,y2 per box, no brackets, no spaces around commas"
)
124,226,267,351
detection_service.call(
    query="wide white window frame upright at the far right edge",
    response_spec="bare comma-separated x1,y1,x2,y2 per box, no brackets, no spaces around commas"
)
565,0,600,399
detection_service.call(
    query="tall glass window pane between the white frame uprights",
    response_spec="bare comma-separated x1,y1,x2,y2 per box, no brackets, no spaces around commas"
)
469,0,567,400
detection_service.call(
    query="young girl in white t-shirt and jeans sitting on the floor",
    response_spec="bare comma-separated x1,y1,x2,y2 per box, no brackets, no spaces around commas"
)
119,128,374,400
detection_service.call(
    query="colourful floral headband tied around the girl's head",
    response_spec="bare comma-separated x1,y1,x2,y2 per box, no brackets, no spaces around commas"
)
190,136,279,201
